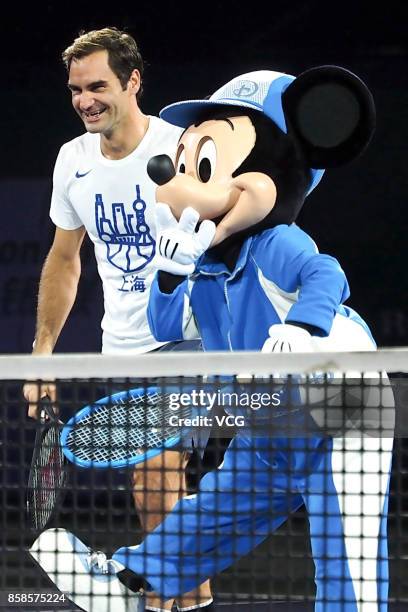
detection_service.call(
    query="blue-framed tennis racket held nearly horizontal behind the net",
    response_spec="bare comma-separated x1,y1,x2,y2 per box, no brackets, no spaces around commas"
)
61,387,192,468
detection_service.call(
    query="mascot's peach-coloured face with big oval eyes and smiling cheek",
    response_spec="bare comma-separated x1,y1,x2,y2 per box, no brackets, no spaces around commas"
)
156,111,276,246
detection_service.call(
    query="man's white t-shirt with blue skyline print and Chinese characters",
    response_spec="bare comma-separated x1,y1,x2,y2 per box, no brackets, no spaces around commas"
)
50,117,181,354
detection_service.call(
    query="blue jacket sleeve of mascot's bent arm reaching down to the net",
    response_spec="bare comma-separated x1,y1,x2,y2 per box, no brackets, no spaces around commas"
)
253,226,350,337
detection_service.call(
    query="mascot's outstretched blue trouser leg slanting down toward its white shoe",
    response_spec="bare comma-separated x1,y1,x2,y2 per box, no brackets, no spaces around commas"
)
113,436,302,599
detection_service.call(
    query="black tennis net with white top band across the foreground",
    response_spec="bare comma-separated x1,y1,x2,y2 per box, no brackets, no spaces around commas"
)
0,349,408,612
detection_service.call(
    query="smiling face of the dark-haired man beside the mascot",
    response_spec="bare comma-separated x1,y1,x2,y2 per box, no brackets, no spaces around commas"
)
68,51,140,136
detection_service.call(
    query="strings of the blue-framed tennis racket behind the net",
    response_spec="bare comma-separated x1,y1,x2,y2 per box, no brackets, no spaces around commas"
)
66,392,191,462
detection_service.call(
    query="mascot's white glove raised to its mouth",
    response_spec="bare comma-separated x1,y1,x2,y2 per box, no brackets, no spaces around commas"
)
154,204,216,276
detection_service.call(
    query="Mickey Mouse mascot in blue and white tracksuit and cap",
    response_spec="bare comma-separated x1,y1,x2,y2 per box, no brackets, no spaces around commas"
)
32,66,392,612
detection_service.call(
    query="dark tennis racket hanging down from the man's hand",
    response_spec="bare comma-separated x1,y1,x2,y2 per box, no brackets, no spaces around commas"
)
26,399,67,531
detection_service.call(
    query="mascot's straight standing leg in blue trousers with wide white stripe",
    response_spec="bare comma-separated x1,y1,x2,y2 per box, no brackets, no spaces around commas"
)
304,438,392,612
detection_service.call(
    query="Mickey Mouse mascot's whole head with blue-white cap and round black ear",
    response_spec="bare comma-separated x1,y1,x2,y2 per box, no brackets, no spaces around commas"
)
147,66,375,246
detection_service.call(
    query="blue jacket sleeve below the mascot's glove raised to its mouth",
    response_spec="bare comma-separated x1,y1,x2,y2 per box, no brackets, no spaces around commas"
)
147,274,199,342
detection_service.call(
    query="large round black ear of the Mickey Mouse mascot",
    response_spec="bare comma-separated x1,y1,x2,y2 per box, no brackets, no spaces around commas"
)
282,66,375,168
